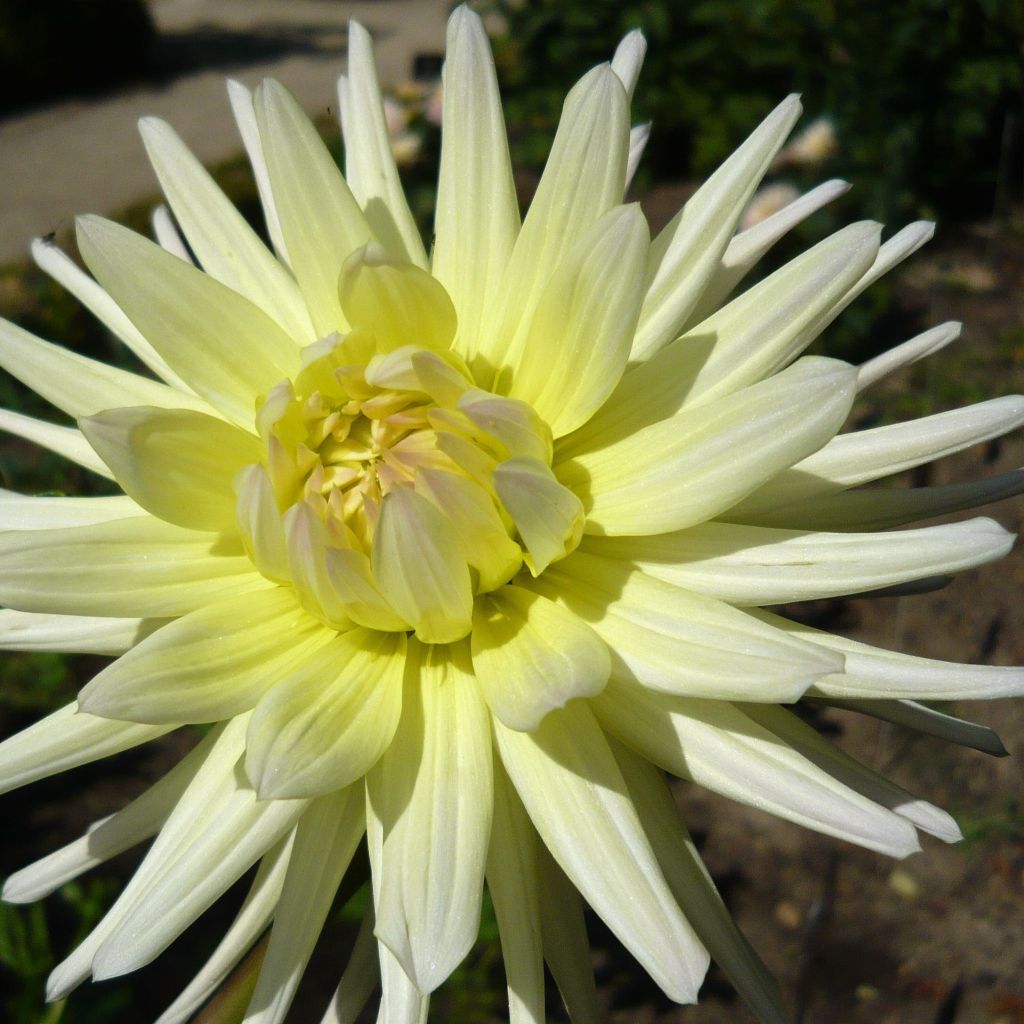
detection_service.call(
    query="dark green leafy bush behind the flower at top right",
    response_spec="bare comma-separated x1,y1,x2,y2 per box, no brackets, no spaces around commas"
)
484,0,1024,221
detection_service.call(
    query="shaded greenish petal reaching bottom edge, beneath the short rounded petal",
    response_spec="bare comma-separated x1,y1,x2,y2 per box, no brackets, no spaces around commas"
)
243,785,366,1024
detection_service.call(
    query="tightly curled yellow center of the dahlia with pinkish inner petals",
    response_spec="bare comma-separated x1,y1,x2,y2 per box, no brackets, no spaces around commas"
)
237,331,583,643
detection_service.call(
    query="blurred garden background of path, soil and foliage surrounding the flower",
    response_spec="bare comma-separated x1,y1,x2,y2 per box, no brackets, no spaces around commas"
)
0,0,1024,1024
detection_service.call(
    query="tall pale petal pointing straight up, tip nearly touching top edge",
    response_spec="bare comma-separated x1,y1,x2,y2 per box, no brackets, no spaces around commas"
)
432,5,519,361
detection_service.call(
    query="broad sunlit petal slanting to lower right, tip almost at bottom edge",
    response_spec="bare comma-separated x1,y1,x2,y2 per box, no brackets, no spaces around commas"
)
495,701,708,1002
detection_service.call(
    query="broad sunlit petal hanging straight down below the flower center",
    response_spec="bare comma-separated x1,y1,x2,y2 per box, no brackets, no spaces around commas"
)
367,643,493,993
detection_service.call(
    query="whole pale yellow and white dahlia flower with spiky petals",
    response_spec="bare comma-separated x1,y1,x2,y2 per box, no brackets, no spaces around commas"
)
0,8,1024,1024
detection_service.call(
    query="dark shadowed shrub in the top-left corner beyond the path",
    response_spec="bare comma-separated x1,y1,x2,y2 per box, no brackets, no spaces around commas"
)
0,0,155,113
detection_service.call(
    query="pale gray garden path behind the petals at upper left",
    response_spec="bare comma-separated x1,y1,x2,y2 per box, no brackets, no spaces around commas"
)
0,0,450,263
